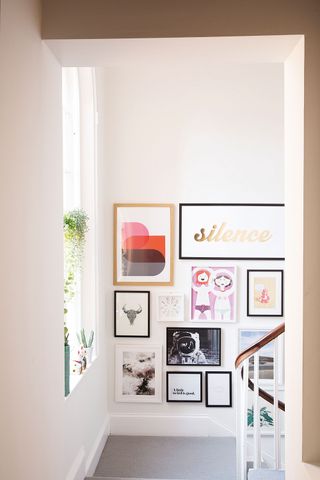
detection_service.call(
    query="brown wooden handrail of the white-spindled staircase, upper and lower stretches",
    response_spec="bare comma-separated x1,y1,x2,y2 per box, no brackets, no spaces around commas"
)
235,323,286,412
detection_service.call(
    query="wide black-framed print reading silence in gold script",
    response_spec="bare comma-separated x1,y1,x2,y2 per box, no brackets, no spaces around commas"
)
179,203,284,260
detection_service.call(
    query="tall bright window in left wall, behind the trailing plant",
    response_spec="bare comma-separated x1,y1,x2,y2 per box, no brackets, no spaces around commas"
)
62,68,97,385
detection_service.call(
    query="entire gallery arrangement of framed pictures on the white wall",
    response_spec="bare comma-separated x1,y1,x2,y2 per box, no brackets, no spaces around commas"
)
113,203,284,406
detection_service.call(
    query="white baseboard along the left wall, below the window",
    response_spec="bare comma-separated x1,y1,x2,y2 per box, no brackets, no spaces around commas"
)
65,417,110,480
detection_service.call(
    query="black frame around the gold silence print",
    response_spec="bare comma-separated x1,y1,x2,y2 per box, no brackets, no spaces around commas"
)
179,203,285,260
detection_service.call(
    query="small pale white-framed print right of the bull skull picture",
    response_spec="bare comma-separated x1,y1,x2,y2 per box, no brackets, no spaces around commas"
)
156,292,184,322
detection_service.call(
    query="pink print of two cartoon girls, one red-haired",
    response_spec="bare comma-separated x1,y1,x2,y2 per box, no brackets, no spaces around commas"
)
191,266,237,322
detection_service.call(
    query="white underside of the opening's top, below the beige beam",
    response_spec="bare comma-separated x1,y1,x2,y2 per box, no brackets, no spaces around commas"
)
45,35,302,67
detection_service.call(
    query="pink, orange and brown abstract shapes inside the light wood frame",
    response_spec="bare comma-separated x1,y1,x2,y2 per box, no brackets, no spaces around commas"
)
121,222,166,277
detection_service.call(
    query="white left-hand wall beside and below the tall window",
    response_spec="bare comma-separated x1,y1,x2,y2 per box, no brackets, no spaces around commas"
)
0,0,107,480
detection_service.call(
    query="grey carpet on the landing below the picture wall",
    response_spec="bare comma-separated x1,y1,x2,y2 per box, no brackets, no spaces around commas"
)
93,436,236,480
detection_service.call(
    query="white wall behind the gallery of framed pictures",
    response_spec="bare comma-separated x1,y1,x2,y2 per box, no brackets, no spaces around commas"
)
98,59,284,434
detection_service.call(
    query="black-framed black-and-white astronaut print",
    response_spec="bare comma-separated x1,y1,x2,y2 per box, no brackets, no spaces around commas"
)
167,327,221,367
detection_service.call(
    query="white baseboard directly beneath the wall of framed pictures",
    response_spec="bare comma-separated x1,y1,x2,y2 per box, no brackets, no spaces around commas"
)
110,414,234,437
